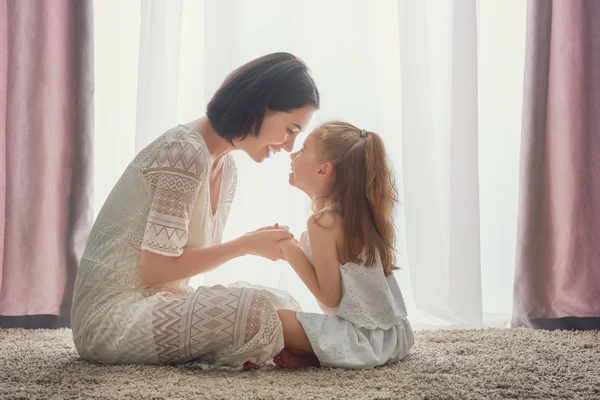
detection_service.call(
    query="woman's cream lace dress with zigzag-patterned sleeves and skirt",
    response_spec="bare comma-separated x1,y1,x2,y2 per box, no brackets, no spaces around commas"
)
72,125,299,368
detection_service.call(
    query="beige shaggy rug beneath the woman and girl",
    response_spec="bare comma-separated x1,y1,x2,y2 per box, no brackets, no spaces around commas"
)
0,329,600,400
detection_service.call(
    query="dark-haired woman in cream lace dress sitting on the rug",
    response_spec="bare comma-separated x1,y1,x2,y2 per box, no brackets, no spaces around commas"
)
72,53,319,368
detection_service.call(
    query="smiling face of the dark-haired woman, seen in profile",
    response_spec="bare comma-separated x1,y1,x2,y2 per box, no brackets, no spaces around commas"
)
235,106,315,163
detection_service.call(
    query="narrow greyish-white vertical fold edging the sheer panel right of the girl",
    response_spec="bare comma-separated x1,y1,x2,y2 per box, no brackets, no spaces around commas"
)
448,0,483,326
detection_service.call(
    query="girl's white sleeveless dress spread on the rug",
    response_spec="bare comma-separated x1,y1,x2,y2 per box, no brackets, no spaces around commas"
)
297,232,414,368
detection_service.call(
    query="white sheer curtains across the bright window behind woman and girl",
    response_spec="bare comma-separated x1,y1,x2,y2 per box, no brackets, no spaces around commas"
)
95,0,525,328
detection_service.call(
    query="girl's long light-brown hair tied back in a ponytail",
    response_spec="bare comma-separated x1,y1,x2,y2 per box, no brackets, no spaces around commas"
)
313,121,398,276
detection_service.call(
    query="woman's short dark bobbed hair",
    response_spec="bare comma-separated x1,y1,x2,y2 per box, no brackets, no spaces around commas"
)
206,53,320,143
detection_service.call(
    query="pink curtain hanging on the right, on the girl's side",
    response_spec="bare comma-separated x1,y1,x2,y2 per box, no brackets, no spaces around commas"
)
513,0,600,329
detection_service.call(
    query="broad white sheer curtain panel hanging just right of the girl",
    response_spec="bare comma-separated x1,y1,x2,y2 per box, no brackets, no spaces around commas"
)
400,0,483,327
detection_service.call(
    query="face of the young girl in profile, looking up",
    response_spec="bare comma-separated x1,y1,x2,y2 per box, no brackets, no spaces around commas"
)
290,133,325,196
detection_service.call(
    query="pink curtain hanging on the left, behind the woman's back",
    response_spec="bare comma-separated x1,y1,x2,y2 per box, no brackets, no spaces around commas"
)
0,0,93,327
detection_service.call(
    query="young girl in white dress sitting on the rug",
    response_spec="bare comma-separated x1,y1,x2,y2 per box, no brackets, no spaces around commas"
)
273,122,414,368
